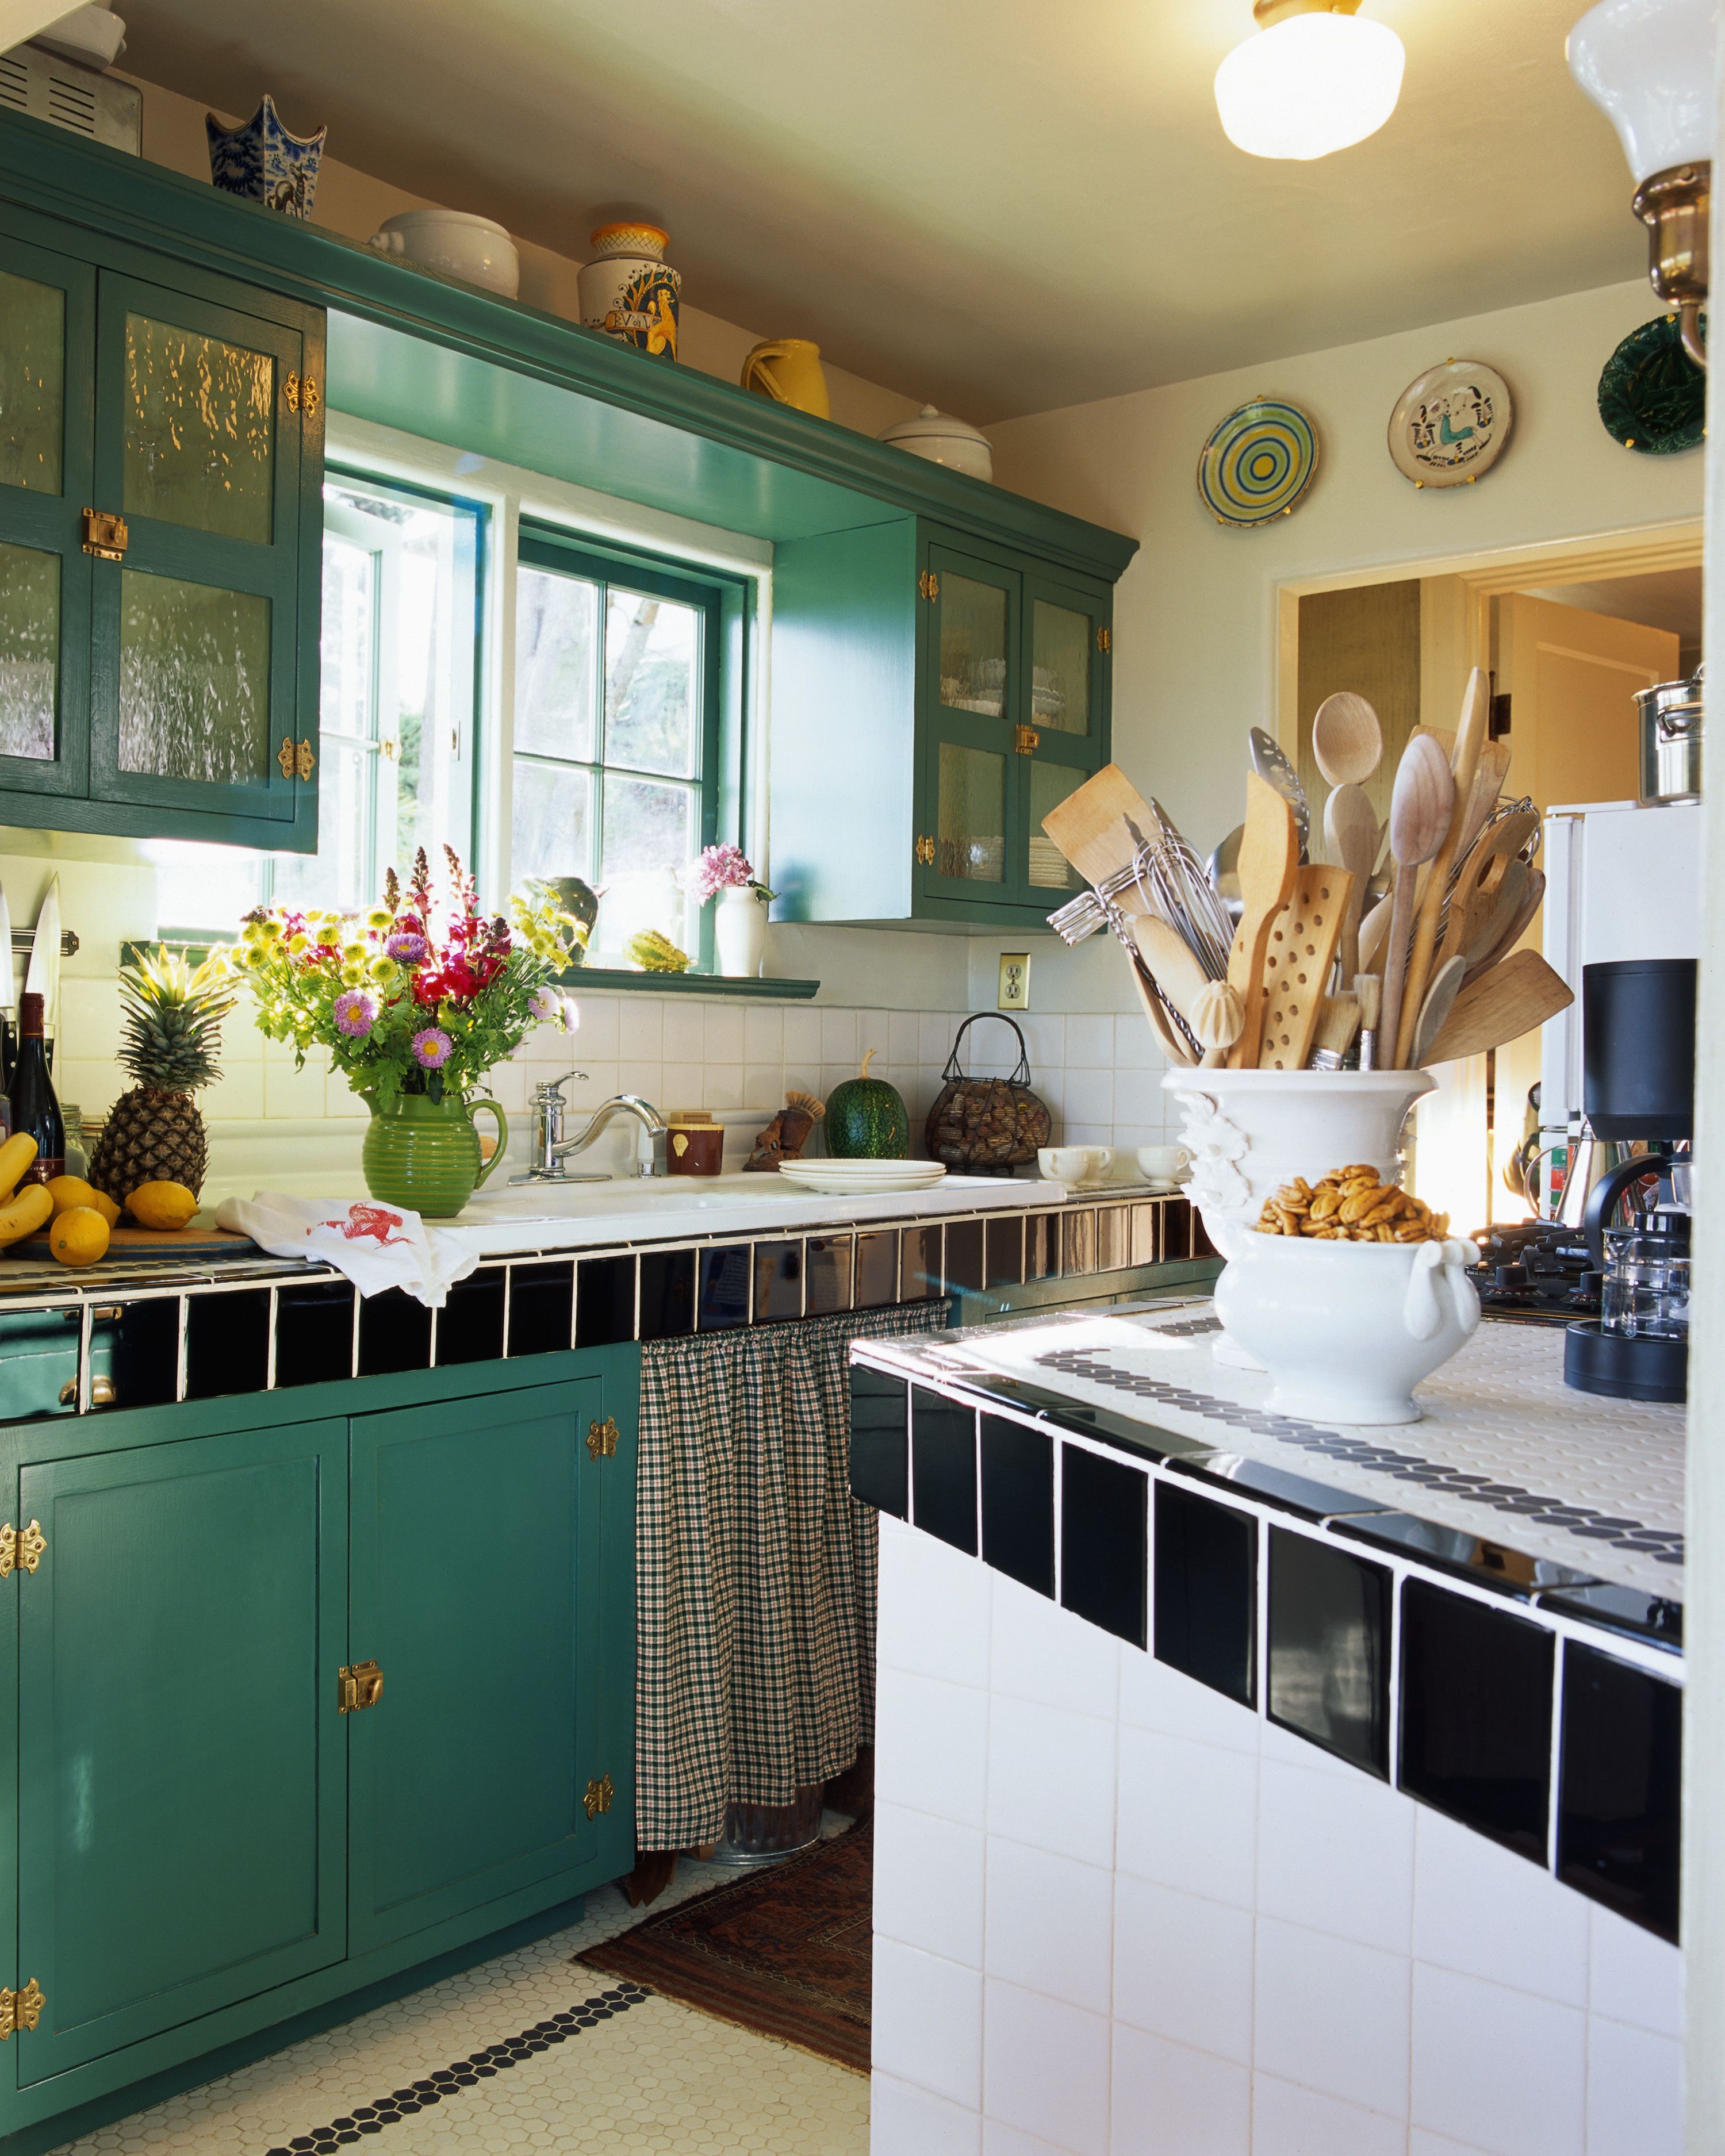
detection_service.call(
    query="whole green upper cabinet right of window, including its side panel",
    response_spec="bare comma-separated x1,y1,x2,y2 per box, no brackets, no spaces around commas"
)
770,520,1113,929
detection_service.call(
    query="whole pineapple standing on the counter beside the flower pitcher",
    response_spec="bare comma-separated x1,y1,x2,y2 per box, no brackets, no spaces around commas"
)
91,951,233,1205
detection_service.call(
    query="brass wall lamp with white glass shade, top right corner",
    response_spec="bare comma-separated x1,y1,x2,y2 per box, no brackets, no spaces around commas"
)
1567,0,1719,367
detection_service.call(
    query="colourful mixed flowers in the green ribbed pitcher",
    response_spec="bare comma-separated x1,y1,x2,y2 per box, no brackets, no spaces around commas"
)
231,847,576,1112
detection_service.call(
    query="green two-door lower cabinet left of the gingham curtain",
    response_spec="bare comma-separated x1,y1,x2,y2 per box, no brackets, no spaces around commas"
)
0,1348,638,2156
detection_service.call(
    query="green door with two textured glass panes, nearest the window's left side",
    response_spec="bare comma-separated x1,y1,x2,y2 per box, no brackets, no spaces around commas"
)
91,272,317,824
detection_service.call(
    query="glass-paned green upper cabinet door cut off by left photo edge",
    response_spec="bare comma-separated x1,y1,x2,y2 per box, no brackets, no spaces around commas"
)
0,235,95,796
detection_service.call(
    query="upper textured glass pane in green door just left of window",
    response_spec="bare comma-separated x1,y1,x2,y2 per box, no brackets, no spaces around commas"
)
125,315,276,546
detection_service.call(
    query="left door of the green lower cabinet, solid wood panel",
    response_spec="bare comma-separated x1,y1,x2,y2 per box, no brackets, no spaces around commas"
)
13,1421,347,2087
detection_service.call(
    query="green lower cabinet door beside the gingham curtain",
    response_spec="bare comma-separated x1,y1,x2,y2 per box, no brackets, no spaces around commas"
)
347,1378,616,1954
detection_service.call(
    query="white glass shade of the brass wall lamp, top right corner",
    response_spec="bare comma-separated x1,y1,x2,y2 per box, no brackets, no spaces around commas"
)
1566,0,1719,186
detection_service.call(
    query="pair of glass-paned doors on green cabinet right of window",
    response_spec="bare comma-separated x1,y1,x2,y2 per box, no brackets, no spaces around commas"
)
917,543,1110,920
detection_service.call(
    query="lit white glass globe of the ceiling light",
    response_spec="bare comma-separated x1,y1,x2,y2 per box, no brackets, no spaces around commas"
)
1216,11,1408,158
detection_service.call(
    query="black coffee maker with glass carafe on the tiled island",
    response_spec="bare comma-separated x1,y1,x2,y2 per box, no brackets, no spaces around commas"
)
1563,957,1697,1399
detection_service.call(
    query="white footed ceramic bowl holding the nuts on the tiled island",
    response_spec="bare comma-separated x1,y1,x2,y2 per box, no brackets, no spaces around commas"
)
1216,1231,1479,1423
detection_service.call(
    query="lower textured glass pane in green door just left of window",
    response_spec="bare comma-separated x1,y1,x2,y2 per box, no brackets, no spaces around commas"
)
118,569,272,785
